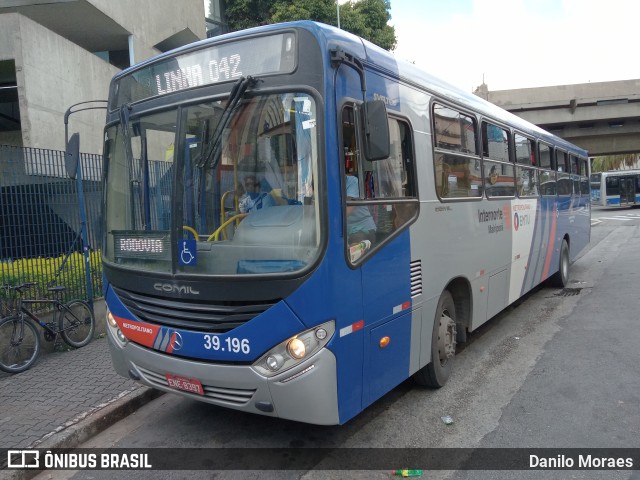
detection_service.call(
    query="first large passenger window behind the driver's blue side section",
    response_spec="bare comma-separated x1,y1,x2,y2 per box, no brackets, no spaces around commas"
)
433,104,482,199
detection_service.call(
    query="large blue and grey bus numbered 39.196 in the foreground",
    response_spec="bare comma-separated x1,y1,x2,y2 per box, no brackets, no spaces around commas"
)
103,21,590,424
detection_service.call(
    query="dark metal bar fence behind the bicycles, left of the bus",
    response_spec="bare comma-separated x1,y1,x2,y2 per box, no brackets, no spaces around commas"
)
0,145,102,308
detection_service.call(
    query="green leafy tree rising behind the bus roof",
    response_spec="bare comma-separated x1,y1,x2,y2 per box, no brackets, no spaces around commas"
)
226,0,397,50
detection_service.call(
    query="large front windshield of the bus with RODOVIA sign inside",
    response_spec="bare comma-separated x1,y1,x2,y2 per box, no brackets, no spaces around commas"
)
105,92,320,275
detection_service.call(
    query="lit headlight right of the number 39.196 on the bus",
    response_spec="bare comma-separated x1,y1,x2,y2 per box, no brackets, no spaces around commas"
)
251,320,336,377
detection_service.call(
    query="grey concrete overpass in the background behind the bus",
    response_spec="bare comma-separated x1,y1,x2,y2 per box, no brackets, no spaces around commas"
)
474,80,640,156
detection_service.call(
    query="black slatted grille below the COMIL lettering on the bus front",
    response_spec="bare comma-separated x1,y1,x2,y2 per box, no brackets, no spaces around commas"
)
113,287,279,333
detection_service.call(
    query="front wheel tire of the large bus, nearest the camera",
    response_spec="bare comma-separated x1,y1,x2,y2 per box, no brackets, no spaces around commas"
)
414,290,457,388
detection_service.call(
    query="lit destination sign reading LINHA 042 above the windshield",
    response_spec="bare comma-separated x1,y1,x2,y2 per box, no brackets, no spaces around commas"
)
109,33,296,110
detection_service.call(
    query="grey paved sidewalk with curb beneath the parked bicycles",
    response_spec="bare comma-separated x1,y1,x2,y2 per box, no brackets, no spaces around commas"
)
0,337,160,449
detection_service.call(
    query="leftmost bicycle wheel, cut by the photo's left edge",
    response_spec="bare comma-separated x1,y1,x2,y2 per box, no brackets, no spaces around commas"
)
0,316,40,373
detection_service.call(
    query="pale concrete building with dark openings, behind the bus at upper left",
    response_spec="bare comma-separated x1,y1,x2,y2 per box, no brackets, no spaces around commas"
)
0,0,205,153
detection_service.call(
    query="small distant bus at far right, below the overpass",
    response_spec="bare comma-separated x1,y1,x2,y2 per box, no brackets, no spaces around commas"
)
590,170,640,207
